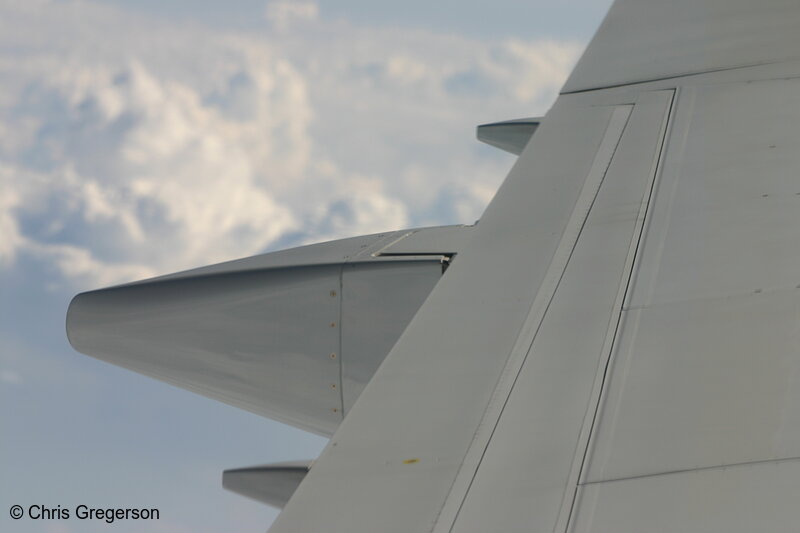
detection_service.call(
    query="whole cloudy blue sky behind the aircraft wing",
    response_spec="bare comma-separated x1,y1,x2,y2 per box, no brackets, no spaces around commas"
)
0,0,610,533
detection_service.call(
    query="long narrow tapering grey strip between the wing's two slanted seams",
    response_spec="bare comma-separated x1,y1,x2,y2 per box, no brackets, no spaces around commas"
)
450,91,673,532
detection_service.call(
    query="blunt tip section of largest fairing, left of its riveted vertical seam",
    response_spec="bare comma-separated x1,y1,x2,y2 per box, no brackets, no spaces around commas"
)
67,265,342,434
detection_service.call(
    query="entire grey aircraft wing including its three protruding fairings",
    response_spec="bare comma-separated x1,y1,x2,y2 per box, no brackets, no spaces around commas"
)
67,0,800,533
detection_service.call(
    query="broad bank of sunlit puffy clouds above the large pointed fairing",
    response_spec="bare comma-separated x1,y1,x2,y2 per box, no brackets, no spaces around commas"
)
0,0,579,286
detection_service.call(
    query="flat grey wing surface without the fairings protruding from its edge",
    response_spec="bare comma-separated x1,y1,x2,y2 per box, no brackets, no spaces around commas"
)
271,0,800,533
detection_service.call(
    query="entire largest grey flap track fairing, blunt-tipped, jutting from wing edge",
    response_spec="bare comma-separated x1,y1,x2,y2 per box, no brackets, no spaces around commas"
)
67,226,469,435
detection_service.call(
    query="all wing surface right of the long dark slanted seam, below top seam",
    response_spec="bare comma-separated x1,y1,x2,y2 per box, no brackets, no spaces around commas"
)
573,57,800,532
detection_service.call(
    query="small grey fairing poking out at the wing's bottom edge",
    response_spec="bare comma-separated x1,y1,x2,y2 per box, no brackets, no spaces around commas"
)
222,461,311,509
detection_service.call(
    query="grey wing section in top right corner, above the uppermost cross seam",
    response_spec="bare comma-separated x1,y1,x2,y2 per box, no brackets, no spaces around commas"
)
563,0,800,93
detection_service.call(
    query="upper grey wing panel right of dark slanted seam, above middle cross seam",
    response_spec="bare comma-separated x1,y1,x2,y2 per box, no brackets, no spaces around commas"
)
629,79,800,307
